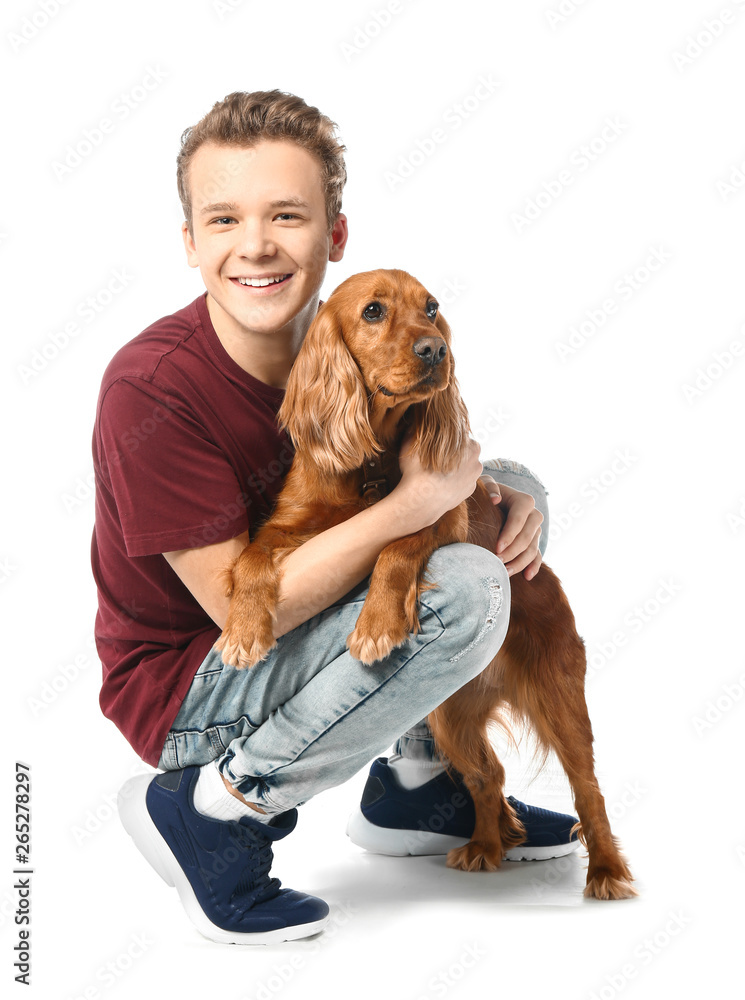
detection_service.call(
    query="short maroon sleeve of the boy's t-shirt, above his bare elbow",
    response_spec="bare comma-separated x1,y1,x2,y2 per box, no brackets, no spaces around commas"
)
94,377,248,556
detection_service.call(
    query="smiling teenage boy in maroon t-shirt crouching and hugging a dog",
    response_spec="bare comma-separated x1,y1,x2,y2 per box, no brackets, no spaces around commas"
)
92,90,576,943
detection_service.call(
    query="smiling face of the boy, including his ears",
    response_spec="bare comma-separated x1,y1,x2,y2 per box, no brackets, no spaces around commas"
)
182,140,347,341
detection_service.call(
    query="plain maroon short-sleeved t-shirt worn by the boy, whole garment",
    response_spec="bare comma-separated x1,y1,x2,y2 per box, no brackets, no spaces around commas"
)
91,295,293,766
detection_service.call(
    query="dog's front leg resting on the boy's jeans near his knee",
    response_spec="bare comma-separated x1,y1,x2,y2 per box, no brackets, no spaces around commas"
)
347,504,468,664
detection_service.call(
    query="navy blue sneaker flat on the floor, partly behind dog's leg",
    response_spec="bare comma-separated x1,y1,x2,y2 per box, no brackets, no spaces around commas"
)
347,757,579,861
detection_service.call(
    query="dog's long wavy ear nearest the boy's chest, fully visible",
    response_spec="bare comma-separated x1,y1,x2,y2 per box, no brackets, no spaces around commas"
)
278,302,381,473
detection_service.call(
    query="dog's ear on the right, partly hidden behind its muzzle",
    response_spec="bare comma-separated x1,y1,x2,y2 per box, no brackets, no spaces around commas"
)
412,314,471,472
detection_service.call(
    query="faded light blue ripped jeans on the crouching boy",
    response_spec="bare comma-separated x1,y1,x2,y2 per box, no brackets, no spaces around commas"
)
159,459,548,813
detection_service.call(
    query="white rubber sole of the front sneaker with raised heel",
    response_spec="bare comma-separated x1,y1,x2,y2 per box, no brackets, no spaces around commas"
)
117,774,329,944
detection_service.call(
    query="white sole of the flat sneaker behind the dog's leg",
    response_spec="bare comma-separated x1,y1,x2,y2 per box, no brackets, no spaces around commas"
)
347,806,579,861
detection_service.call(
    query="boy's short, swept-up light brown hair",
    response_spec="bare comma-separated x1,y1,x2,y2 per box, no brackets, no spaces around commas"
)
176,90,347,237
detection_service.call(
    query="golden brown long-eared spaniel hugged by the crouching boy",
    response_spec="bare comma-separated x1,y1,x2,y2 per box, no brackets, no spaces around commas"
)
217,270,636,899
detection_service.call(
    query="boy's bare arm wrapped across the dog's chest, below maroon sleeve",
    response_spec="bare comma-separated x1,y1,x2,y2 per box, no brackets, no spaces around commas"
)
164,434,482,638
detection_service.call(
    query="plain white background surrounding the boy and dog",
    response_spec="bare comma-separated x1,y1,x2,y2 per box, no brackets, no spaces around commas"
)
0,0,745,1000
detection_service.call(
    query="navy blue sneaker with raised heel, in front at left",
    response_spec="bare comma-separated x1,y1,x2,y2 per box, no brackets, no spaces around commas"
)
118,767,329,944
